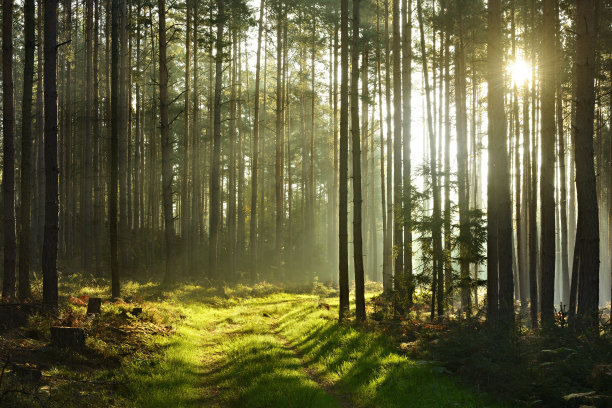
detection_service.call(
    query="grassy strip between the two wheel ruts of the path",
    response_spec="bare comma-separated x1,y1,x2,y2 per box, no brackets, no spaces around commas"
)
202,299,344,408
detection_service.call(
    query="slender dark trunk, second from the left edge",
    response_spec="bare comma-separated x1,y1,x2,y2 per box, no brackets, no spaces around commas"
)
18,0,36,301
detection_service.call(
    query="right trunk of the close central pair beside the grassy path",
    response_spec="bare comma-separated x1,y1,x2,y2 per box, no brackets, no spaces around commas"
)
352,0,366,321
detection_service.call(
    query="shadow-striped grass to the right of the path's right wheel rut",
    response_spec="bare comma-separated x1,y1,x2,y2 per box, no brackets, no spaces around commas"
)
278,306,511,408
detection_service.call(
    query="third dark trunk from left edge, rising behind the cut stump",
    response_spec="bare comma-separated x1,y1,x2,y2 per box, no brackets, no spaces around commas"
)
42,0,59,309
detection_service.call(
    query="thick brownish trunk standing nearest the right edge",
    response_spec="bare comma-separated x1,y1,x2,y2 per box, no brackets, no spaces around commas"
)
572,0,599,330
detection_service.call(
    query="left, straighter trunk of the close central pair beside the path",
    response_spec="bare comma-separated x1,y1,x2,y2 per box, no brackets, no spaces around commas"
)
338,0,349,320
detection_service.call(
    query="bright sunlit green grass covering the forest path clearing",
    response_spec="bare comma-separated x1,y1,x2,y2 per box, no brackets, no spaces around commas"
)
106,286,508,408
